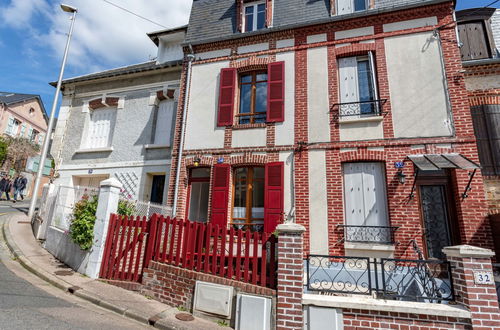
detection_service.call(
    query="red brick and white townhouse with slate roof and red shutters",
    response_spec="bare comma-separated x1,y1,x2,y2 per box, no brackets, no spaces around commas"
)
167,0,493,258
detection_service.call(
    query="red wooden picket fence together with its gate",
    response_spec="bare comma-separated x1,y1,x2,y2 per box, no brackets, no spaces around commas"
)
100,214,277,288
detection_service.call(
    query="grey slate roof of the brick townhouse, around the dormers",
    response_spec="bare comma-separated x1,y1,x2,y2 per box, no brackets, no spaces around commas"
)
185,0,450,44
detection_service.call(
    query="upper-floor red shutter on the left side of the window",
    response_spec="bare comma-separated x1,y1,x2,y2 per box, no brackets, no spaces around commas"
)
217,68,236,126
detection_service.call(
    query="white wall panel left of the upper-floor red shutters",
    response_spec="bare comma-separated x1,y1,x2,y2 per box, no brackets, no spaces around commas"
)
184,61,229,150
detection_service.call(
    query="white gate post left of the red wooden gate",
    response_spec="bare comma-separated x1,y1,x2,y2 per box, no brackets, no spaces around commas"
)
85,178,122,278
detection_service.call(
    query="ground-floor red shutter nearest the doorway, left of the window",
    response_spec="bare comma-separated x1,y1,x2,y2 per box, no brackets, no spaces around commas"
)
210,164,231,227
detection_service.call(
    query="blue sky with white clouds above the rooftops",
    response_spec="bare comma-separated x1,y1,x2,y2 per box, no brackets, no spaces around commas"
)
0,0,500,116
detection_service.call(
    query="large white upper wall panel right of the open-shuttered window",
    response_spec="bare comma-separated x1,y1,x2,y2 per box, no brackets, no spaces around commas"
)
385,32,452,138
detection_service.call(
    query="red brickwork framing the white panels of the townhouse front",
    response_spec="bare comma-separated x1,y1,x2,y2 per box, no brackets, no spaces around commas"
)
168,2,493,257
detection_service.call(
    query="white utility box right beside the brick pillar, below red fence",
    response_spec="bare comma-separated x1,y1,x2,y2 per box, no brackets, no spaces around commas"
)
235,294,272,330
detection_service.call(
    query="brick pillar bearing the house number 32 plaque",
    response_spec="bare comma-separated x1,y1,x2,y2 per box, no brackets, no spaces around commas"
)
443,245,500,329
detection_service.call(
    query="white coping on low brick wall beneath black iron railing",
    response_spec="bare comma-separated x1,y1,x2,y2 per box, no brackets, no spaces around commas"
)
302,293,472,319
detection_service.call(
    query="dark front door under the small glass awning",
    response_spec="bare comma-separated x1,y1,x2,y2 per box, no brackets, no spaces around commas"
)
419,171,458,259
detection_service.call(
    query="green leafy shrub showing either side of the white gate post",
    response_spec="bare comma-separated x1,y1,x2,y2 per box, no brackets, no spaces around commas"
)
69,195,135,251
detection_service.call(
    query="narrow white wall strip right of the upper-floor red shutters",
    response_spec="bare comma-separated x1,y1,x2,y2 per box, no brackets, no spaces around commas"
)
274,52,295,146
